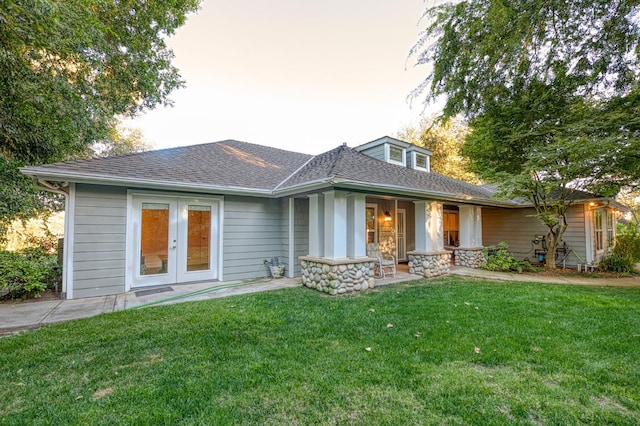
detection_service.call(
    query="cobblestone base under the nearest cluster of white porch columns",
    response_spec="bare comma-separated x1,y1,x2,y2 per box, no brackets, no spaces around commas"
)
300,257,376,295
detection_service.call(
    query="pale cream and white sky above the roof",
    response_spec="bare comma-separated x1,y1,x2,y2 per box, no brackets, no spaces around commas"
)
127,0,430,154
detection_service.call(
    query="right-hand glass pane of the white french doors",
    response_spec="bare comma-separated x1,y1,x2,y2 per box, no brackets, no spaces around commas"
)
187,205,211,272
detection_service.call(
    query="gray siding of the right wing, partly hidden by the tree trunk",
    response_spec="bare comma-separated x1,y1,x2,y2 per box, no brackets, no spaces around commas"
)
482,205,586,266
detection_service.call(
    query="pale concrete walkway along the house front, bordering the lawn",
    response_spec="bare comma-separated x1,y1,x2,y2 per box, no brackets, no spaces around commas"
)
0,267,640,336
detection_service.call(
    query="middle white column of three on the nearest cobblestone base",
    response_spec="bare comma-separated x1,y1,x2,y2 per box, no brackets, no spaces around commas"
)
324,191,347,259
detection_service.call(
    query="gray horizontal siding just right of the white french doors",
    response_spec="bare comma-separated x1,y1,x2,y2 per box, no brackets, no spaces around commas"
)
222,196,287,281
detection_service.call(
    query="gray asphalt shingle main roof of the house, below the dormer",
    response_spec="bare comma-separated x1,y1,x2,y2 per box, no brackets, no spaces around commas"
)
24,140,502,201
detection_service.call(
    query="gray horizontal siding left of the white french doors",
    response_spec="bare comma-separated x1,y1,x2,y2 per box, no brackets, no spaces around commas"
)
73,184,127,298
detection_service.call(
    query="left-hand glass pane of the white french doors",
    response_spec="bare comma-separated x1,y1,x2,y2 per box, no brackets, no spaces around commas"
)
140,203,169,275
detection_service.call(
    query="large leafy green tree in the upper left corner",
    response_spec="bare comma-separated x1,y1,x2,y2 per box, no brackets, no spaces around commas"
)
0,0,198,233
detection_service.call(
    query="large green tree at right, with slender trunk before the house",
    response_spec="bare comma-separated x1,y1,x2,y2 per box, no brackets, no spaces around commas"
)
411,0,640,267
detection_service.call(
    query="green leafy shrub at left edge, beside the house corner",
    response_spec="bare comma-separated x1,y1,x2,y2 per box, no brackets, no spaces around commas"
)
0,248,60,299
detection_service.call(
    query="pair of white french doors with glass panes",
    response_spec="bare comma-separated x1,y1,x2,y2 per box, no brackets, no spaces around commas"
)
131,195,219,287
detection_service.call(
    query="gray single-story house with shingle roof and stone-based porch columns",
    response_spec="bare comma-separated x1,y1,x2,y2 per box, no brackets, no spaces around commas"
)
22,136,615,299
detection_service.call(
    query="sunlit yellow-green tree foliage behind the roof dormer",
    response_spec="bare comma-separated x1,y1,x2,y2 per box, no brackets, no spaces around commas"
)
398,116,479,184
